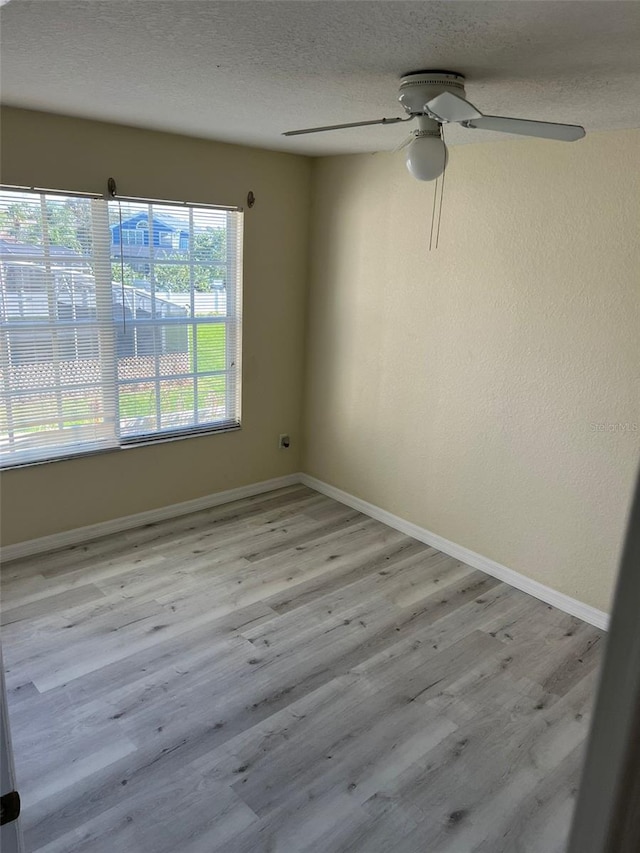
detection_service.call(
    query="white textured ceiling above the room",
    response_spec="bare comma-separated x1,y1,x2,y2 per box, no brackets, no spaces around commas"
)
0,0,640,154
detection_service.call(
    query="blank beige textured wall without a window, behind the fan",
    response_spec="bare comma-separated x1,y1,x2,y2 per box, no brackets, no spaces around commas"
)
303,131,640,609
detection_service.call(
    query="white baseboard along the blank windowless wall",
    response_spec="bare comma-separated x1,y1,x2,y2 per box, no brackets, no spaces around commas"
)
300,474,609,631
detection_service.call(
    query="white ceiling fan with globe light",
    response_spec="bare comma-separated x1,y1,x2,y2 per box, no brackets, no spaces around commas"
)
283,71,584,181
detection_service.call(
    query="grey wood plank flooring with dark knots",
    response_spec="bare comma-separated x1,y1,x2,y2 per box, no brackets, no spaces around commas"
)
2,486,602,853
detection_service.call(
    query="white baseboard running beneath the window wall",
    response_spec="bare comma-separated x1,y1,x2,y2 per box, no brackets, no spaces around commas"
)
2,474,301,563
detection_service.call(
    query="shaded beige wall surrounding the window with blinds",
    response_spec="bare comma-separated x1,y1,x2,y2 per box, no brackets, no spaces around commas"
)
0,109,310,544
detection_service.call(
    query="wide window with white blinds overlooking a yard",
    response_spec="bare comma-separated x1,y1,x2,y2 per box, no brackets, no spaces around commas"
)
0,189,242,466
